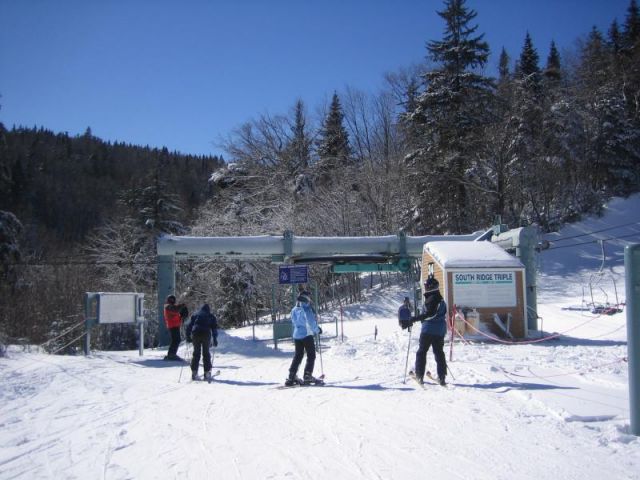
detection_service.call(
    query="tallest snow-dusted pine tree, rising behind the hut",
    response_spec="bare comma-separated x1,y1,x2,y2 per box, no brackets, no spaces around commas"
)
407,0,493,232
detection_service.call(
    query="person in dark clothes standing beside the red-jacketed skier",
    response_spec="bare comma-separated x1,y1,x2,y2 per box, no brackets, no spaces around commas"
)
187,303,218,380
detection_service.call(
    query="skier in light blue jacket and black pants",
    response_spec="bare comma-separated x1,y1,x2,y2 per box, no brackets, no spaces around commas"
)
284,291,322,387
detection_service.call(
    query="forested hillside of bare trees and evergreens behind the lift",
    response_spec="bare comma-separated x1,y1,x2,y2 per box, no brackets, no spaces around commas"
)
0,0,640,347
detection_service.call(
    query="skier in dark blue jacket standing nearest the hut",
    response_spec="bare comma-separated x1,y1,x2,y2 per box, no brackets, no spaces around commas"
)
402,275,447,386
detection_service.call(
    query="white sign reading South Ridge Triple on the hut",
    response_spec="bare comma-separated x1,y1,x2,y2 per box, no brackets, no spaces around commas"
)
453,270,517,308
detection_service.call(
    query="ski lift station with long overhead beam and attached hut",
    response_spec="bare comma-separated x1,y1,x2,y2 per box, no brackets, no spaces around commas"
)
157,225,537,345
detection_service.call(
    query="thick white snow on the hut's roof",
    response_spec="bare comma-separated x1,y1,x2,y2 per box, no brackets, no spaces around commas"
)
423,241,524,268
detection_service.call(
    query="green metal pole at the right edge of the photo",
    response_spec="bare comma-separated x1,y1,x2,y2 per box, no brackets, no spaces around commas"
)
624,244,640,436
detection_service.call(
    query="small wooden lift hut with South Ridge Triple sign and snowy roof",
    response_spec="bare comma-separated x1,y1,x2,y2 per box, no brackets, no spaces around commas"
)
421,241,527,338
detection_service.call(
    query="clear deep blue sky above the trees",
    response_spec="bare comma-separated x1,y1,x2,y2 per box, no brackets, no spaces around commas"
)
0,0,629,158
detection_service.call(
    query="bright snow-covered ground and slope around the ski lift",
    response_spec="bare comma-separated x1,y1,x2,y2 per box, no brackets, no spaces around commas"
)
0,196,640,480
